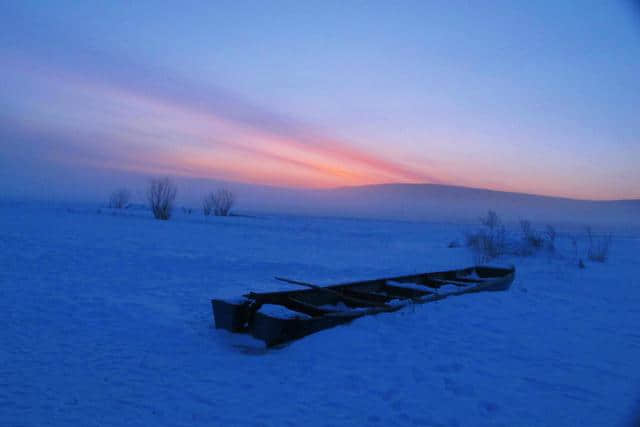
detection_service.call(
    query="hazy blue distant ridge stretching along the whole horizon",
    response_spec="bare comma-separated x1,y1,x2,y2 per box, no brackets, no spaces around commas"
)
0,169,640,226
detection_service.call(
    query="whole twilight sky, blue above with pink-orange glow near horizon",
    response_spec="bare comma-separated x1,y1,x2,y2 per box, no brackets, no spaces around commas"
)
0,1,640,199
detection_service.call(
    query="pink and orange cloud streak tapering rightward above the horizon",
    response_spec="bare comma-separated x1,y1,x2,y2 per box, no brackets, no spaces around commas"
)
0,49,440,187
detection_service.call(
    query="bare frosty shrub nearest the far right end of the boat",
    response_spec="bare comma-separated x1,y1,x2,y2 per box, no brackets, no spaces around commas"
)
465,211,506,262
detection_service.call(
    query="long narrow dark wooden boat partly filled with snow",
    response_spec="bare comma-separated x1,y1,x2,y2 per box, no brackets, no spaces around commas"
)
211,266,515,346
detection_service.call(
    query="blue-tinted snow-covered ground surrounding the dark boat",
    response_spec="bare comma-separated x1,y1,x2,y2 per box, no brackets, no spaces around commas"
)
0,203,640,427
